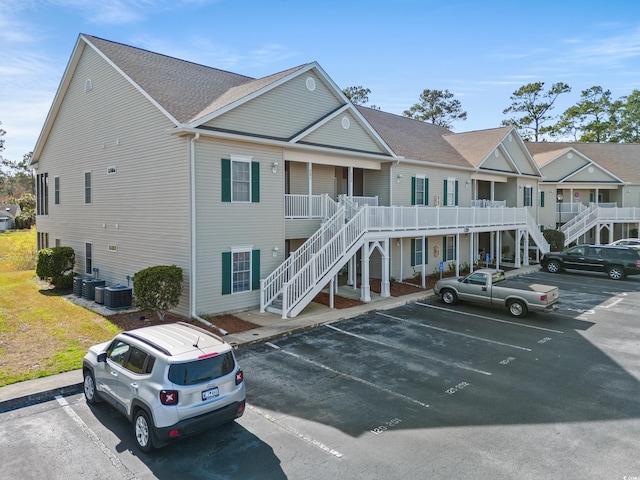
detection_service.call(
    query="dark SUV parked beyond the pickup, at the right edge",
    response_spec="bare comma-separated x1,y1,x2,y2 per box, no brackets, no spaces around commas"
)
540,245,640,280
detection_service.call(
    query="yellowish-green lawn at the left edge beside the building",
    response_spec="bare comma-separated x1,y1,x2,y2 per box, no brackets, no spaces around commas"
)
0,230,118,386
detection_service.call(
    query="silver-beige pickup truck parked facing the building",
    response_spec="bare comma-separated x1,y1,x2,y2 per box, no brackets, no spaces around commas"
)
433,268,560,317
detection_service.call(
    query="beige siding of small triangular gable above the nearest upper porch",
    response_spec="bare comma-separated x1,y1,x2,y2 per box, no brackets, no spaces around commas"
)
300,112,384,153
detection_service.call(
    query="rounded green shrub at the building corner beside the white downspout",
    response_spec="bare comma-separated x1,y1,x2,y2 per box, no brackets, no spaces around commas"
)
133,265,182,321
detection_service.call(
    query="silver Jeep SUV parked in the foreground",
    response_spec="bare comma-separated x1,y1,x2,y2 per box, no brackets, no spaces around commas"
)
82,322,246,452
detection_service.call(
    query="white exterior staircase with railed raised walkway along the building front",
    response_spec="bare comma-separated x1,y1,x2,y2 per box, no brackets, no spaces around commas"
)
260,202,549,318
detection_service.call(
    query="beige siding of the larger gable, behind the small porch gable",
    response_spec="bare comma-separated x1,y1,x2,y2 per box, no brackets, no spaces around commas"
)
205,72,342,139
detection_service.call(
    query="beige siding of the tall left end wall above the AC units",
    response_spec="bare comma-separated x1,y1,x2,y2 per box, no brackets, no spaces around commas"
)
37,44,189,313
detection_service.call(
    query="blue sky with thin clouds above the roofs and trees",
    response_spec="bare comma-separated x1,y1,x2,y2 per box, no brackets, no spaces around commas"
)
0,0,640,161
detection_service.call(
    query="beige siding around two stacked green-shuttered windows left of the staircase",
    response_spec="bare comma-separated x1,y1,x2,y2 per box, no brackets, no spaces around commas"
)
190,138,285,314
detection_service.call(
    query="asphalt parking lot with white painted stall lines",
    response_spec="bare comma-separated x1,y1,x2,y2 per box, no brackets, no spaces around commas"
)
0,272,640,479
